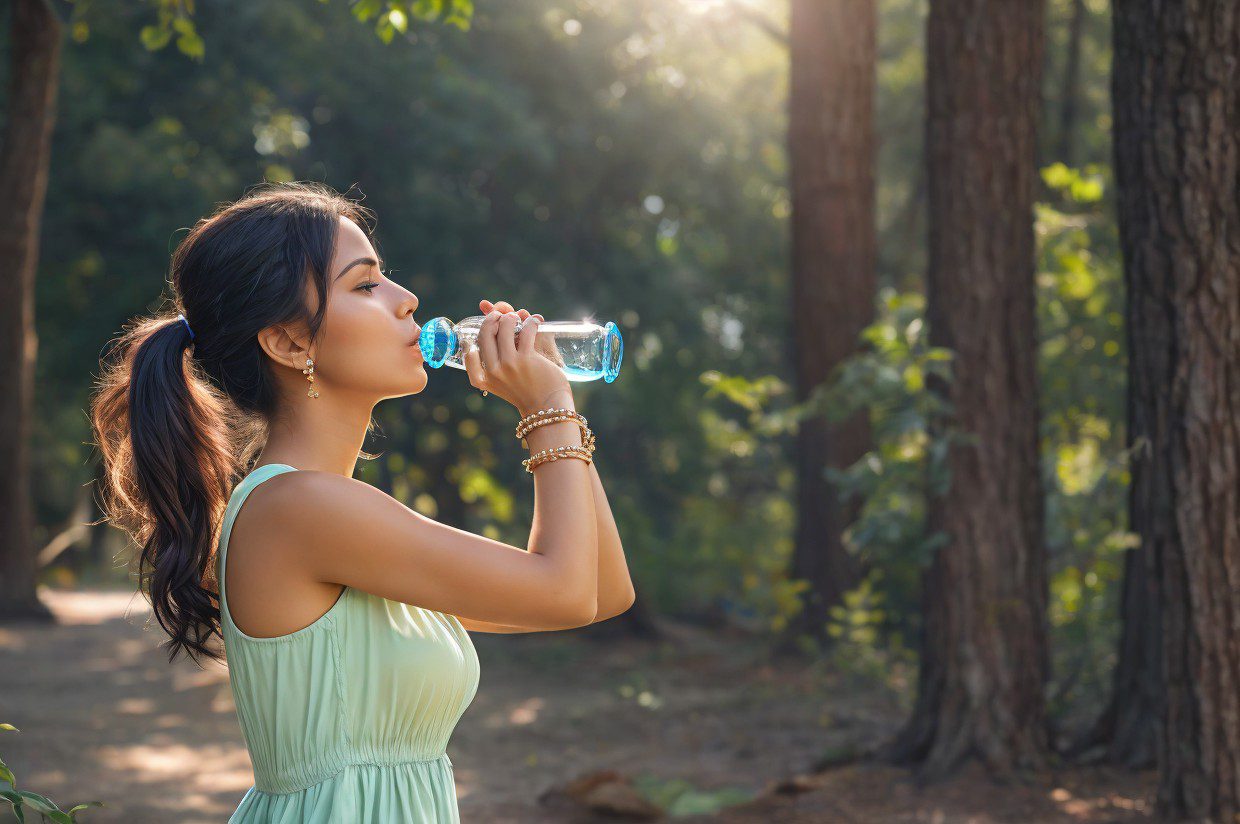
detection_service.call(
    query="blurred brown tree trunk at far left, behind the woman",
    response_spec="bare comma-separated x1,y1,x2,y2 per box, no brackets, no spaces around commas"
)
0,0,61,620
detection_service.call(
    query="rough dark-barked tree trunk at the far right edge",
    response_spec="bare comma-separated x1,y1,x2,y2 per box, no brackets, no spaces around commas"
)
1112,0,1240,822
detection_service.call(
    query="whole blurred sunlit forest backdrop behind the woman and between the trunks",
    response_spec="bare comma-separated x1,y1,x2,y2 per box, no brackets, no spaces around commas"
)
0,0,1230,820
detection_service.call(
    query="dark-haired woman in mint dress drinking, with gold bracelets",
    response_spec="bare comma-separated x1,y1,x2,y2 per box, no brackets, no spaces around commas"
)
91,183,632,823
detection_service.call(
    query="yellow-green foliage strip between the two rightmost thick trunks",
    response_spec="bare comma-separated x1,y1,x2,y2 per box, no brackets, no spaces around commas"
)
1035,164,1136,714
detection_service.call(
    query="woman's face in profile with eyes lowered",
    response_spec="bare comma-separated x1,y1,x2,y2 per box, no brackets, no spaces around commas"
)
306,217,427,403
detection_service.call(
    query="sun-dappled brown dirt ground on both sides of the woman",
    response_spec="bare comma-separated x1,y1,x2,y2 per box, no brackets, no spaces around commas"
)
0,589,1154,824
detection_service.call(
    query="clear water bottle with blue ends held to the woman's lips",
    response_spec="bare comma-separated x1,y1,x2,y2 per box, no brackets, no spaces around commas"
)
418,315,624,383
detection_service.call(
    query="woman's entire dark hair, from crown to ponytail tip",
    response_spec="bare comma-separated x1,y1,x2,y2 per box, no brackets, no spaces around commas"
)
89,182,373,664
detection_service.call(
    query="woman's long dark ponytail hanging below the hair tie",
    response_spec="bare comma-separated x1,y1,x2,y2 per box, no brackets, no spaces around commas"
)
91,316,238,662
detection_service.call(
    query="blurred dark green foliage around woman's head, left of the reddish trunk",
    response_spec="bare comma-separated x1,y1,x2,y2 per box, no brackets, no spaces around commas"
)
43,0,792,613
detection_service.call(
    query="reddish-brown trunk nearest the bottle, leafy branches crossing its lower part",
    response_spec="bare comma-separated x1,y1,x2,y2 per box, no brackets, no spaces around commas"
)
785,0,877,641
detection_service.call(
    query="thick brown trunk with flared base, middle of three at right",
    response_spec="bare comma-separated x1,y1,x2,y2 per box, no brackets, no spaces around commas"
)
888,0,1049,779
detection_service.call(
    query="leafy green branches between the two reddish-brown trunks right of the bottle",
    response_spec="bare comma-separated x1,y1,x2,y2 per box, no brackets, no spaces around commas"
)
704,287,970,643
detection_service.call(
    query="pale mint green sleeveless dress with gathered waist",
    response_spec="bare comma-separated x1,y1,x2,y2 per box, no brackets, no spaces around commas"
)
216,463,479,824
